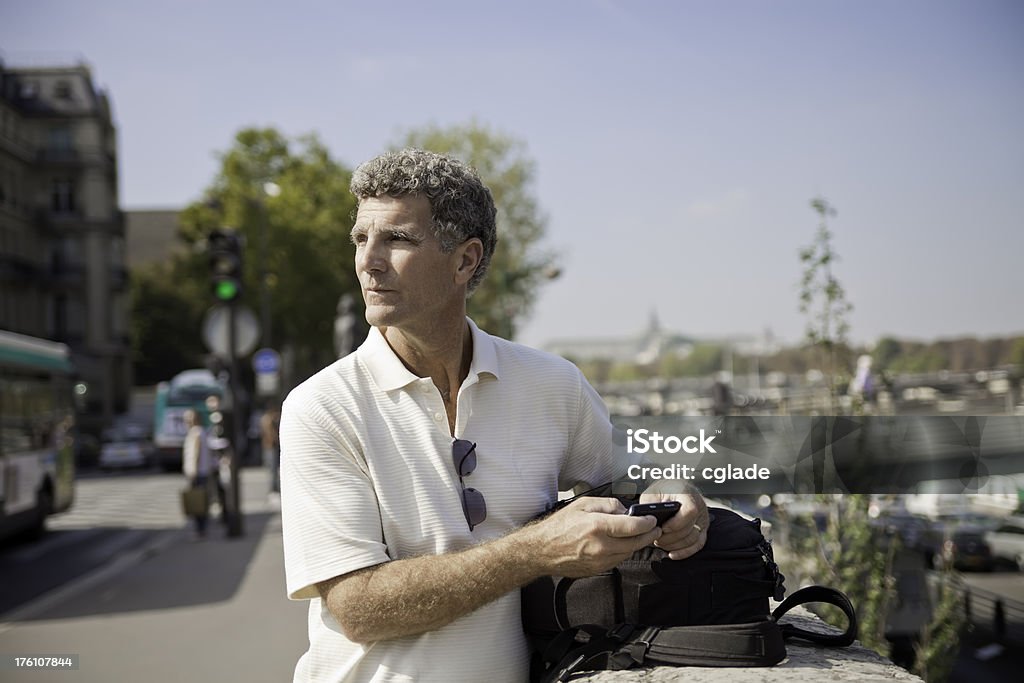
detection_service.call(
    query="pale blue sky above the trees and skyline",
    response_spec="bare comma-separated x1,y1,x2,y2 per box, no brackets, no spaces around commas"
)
0,0,1024,345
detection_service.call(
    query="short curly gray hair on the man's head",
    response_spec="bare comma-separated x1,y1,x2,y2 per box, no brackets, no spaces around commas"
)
349,148,498,293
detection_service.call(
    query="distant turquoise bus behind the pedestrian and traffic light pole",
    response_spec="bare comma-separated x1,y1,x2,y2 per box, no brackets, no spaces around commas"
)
153,370,224,471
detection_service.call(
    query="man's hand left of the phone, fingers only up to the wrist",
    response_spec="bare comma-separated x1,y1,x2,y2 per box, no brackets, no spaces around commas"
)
523,498,667,578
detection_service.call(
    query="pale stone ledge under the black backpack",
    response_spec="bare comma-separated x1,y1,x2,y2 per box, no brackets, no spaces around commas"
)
572,607,923,683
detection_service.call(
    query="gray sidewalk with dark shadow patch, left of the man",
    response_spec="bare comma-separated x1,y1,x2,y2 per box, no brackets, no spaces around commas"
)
0,469,307,683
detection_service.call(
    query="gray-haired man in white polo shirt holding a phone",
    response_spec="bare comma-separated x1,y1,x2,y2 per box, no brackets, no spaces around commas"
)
281,150,708,681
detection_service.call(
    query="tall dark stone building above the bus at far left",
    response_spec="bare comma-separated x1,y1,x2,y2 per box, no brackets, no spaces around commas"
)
0,62,131,431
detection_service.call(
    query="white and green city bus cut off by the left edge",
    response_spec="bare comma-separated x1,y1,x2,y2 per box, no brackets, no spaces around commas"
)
0,330,77,539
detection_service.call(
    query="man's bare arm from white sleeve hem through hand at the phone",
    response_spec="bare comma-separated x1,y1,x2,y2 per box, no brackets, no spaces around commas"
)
317,498,662,643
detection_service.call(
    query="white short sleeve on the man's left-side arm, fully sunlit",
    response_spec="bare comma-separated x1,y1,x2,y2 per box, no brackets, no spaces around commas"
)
281,392,390,600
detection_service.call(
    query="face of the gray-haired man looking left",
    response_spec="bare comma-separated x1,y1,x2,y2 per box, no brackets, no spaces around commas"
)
352,197,465,331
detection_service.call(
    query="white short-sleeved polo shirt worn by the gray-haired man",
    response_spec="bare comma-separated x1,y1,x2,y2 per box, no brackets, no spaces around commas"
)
281,318,625,683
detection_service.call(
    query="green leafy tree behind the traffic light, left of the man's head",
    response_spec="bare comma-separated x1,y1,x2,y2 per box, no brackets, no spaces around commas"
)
177,128,361,381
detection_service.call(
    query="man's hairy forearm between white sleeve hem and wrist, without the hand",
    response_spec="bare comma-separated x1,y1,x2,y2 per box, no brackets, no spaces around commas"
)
317,527,546,643
